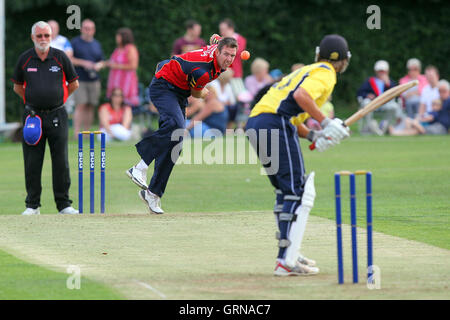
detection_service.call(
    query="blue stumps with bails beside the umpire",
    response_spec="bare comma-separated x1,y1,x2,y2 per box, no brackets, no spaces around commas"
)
78,131,106,213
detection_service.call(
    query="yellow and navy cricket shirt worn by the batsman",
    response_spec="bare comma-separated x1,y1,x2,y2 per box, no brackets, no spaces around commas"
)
250,62,336,126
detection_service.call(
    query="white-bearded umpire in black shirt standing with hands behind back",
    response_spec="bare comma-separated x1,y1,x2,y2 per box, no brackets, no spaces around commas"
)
12,21,78,215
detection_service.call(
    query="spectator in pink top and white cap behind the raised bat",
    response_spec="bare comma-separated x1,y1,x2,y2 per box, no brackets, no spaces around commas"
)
400,58,428,118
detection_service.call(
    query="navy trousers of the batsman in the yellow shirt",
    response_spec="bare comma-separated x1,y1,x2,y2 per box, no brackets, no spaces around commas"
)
245,113,305,259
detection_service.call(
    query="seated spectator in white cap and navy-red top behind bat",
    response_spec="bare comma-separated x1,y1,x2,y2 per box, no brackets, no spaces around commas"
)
357,60,403,135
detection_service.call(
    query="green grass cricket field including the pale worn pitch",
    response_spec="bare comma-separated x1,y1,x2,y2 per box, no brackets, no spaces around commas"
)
0,136,450,299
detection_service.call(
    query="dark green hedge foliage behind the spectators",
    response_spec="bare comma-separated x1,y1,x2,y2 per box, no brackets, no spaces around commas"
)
6,0,450,121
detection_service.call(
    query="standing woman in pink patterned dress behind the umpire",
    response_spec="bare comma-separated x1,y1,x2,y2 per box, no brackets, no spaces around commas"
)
105,28,139,106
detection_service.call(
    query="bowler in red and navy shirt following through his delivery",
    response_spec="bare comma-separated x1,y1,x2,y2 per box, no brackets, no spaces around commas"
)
126,35,238,213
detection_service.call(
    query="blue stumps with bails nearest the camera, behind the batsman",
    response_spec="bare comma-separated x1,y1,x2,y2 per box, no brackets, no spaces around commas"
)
334,170,373,284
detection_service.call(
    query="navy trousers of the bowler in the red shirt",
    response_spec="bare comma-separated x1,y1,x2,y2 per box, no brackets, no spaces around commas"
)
136,77,190,197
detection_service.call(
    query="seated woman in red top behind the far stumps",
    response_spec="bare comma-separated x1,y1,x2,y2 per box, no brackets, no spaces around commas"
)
98,88,133,141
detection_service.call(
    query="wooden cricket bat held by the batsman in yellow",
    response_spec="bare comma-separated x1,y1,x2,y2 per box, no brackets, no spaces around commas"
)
309,80,419,150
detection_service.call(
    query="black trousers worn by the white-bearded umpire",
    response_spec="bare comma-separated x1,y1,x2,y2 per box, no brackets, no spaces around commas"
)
22,106,72,211
